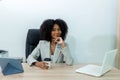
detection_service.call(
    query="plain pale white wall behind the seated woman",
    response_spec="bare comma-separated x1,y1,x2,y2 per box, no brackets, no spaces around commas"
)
0,0,117,63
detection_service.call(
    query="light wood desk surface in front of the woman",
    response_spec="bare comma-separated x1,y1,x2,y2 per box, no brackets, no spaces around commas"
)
0,63,120,80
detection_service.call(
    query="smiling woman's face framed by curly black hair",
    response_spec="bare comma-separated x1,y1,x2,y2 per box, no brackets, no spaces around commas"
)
51,24,62,39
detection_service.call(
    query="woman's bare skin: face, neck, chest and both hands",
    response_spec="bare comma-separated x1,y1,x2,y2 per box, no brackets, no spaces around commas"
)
35,24,65,69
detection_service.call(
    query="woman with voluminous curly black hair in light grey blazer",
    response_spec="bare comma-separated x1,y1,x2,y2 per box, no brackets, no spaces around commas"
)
27,19,73,69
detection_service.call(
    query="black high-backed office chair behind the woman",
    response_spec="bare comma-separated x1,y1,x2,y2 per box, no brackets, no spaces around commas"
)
25,29,41,61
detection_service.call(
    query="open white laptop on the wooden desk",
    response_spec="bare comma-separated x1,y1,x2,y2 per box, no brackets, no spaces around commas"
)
75,49,117,77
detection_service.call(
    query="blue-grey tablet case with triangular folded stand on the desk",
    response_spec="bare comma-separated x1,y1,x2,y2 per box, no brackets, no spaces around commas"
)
0,58,24,75
